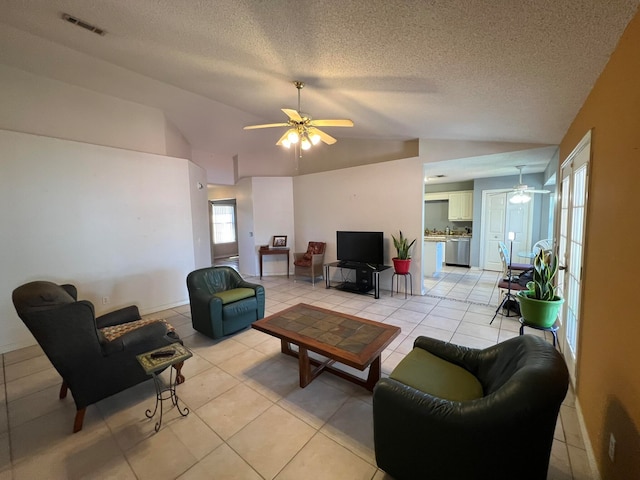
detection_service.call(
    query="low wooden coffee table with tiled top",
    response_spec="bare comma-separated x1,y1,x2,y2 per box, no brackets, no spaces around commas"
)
251,303,400,391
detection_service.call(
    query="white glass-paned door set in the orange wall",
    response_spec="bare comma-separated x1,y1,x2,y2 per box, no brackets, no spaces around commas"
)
558,128,591,385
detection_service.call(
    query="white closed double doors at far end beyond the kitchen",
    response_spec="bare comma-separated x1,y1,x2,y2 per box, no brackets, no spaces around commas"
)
480,190,533,271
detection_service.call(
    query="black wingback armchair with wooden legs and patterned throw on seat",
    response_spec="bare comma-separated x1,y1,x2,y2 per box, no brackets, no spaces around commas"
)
13,281,184,433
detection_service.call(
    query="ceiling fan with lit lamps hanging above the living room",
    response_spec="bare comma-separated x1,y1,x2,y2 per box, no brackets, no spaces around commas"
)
244,81,353,150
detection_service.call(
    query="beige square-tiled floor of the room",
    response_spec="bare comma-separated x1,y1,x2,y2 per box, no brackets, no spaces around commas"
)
0,268,592,480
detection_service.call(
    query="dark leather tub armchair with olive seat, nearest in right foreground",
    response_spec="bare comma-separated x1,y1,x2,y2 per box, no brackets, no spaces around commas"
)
373,335,569,480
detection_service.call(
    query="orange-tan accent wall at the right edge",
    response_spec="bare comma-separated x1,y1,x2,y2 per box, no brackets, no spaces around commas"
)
560,8,640,480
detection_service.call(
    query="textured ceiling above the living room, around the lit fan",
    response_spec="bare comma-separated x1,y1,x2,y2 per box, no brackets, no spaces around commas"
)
0,0,640,180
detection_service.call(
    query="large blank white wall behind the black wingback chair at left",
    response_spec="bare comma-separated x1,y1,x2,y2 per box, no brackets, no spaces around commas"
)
0,131,208,352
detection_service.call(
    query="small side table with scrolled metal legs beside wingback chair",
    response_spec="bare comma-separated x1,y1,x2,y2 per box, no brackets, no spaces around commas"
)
136,343,193,432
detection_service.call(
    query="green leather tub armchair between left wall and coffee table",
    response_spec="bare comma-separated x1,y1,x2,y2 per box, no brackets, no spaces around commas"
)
187,267,265,338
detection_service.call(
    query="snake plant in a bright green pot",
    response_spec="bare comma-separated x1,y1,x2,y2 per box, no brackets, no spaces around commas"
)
517,249,564,328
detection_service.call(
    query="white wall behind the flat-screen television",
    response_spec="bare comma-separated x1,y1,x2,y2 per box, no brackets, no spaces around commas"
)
293,157,424,294
